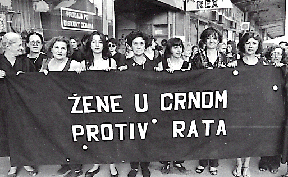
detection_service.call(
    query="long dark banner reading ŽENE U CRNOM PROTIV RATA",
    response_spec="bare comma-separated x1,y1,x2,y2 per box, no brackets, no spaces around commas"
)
6,66,285,166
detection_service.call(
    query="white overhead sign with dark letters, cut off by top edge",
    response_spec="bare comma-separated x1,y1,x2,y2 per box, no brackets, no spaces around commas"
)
186,0,233,11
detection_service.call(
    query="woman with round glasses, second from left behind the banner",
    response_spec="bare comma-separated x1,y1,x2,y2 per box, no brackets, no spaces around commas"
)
26,32,47,71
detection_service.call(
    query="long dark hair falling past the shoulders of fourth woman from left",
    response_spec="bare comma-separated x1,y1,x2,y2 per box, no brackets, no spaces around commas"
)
85,31,110,66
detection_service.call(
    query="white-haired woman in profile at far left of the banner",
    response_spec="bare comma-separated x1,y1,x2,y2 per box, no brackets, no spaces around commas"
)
0,32,38,177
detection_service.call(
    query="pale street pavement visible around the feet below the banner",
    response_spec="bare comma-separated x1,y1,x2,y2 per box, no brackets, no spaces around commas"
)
0,157,287,177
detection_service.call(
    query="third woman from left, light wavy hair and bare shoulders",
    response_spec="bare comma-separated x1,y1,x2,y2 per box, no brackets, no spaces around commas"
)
40,36,84,176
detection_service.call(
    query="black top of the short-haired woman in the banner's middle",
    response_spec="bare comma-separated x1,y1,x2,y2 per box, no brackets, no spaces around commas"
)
126,54,161,71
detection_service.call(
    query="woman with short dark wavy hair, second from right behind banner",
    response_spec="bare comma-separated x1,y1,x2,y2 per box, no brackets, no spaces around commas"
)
232,33,267,177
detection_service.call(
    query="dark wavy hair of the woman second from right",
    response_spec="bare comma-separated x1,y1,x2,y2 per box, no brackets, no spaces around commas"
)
238,32,263,54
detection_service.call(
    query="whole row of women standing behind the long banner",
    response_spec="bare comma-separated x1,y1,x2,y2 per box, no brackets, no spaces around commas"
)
0,27,288,177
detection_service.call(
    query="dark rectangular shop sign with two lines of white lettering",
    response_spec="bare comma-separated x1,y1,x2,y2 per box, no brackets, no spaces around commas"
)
61,7,96,31
